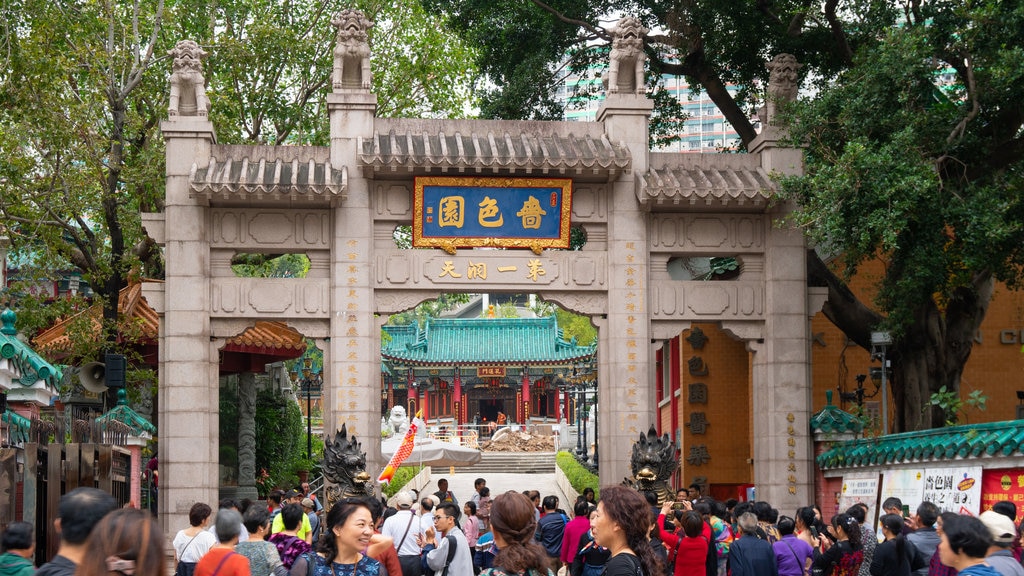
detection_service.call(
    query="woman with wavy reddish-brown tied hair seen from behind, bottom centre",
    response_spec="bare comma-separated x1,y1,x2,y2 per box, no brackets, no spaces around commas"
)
480,491,552,576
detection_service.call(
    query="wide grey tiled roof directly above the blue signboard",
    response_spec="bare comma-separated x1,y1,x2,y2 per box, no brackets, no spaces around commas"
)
358,120,632,179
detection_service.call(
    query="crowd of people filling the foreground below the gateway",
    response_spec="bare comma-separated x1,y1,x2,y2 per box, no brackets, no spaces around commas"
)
0,478,1024,576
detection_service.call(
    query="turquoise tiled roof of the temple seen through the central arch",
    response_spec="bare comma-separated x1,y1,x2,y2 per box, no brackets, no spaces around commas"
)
381,316,596,366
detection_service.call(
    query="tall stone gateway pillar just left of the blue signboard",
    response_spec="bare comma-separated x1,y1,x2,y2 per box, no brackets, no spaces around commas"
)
324,88,384,467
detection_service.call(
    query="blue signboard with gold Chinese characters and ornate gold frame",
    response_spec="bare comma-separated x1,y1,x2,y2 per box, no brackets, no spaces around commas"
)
413,176,572,254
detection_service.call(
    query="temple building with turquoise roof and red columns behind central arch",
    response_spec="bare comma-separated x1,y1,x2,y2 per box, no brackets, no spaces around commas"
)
381,316,597,426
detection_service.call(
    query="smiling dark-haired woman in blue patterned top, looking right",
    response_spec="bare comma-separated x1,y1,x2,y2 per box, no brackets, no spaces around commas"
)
303,498,387,576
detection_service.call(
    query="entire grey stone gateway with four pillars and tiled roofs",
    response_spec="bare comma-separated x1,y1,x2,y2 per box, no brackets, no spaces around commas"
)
143,10,812,526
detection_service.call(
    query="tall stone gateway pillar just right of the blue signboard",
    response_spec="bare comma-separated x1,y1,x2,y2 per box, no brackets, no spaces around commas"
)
594,93,656,485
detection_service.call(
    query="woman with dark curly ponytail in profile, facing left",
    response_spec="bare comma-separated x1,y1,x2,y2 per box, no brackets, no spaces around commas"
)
590,486,664,576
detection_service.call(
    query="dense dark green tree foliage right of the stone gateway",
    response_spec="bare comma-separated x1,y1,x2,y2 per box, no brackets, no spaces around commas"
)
782,1,1024,336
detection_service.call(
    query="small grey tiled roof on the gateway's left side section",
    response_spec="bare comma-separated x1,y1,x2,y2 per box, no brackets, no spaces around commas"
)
188,146,348,201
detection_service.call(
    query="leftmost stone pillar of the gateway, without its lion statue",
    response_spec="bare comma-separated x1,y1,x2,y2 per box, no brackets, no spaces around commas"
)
159,111,219,533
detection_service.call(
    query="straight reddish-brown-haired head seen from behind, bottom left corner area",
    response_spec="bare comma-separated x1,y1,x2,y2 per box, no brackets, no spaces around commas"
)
75,508,166,576
